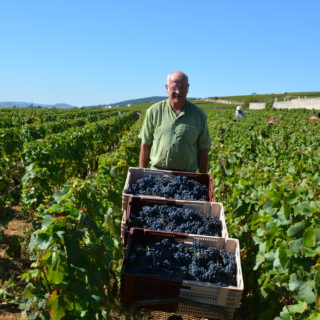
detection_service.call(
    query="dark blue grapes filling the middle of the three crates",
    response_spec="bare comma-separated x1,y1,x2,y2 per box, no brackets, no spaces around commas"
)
129,205,222,237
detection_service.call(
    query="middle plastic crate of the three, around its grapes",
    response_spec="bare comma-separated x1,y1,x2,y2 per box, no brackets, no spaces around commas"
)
121,196,228,243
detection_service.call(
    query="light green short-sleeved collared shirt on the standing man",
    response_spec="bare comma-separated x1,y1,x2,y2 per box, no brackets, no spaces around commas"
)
139,99,211,171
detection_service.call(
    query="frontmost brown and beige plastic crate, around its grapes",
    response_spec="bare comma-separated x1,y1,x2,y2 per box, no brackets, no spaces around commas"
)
120,228,243,319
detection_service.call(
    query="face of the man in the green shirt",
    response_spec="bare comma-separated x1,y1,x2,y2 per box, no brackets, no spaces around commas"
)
166,78,189,108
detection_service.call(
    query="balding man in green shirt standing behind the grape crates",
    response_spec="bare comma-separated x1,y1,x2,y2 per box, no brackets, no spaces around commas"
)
139,71,211,173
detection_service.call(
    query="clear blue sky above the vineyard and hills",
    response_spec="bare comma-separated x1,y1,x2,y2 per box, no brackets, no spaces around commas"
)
0,0,320,106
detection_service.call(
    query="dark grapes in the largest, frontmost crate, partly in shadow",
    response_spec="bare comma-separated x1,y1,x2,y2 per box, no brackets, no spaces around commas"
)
126,239,237,286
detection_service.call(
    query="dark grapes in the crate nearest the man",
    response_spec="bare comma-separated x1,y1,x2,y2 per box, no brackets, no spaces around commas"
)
129,174,209,201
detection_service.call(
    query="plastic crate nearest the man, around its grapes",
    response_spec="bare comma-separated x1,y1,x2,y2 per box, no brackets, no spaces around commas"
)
122,167,214,211
